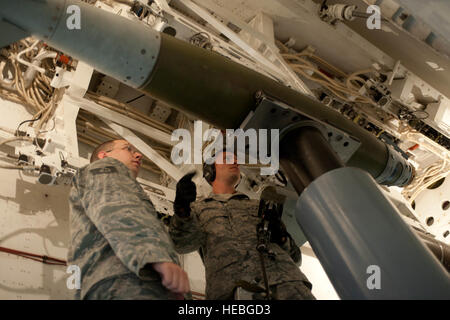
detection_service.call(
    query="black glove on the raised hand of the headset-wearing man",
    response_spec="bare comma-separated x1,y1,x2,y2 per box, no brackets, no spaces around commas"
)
173,171,197,217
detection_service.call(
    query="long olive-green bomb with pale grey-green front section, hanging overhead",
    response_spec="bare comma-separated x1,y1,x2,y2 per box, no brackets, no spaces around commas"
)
0,0,407,185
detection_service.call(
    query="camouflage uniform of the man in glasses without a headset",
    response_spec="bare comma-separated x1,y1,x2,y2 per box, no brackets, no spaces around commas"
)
68,157,179,299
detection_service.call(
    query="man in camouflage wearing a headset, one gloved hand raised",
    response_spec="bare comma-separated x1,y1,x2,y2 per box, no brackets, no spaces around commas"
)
169,151,314,300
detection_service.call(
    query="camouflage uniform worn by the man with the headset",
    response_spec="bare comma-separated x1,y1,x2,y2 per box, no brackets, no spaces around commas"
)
169,193,314,300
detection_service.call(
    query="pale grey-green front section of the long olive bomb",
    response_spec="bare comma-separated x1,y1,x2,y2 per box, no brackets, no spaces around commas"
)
0,0,161,88
